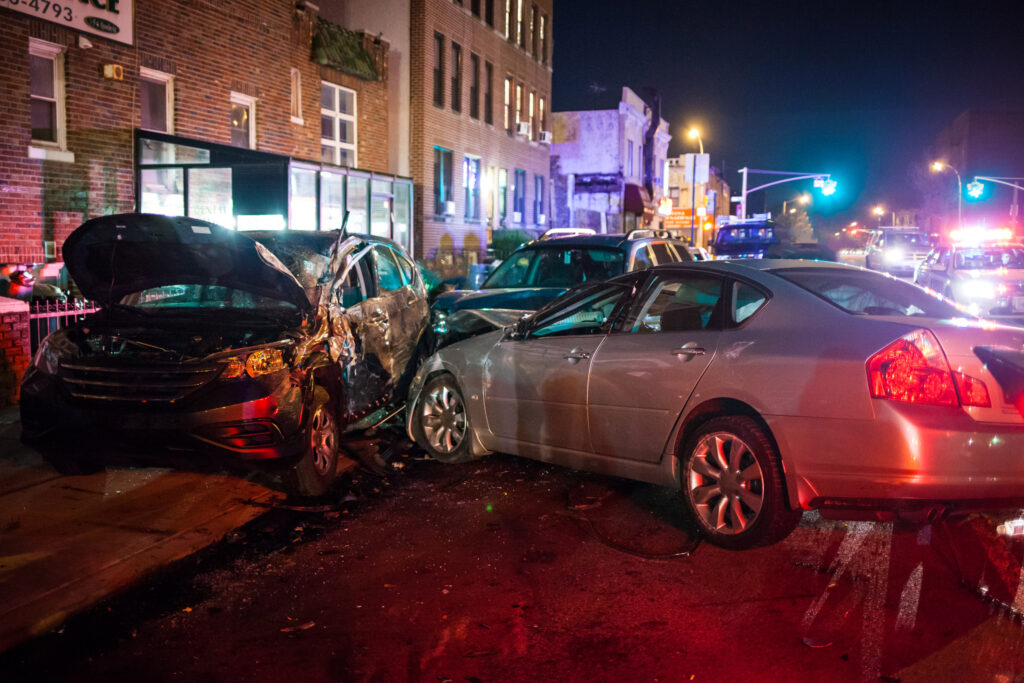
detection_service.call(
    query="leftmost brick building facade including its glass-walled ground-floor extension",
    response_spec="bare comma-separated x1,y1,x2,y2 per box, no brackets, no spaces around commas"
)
0,0,412,264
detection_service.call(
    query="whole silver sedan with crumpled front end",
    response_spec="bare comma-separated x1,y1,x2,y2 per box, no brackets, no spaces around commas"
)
408,259,1024,549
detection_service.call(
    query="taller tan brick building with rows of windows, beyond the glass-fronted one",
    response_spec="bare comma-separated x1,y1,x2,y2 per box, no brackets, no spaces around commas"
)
409,0,553,273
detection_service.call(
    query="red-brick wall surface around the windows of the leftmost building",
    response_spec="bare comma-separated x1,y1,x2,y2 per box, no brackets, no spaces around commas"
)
0,0,388,263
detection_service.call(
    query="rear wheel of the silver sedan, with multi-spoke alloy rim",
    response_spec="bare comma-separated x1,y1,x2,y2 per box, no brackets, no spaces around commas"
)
680,415,803,550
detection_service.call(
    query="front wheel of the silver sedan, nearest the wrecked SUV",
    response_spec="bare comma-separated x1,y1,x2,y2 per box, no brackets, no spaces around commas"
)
411,374,475,463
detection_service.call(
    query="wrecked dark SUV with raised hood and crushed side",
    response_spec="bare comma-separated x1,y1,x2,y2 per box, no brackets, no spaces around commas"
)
20,214,429,496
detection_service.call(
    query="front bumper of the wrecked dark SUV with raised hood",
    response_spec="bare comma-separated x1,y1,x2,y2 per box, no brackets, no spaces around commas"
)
20,369,305,469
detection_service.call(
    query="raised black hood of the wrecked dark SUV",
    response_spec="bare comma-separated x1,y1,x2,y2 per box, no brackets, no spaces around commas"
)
63,213,310,311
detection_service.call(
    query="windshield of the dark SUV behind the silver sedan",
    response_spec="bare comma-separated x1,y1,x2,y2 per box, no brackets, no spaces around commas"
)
480,246,626,290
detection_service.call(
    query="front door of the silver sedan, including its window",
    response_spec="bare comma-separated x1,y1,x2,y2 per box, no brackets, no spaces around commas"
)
482,281,633,455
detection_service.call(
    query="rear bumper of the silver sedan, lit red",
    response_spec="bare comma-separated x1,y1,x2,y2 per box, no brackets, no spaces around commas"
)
767,400,1024,510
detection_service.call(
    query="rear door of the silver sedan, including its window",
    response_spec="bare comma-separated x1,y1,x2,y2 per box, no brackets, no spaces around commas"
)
587,270,742,462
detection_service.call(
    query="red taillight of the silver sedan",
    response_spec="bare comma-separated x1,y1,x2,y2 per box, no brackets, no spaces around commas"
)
867,330,991,408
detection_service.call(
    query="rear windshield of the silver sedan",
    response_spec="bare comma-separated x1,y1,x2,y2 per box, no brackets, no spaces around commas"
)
771,268,966,317
